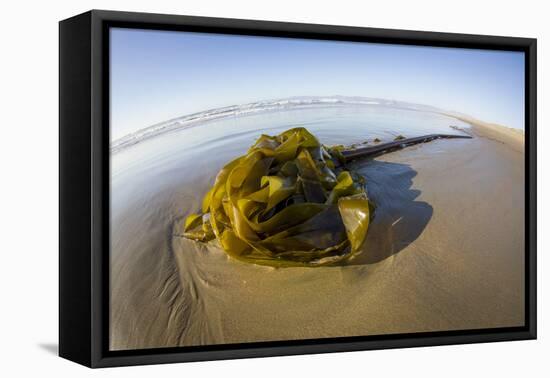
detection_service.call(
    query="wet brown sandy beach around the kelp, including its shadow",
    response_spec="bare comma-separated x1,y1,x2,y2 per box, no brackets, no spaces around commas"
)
110,120,525,350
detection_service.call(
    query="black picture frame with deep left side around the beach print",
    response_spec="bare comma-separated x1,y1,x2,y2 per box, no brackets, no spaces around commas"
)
59,10,537,367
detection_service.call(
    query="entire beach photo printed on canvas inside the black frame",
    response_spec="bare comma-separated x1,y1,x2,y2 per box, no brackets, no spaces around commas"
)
109,28,526,351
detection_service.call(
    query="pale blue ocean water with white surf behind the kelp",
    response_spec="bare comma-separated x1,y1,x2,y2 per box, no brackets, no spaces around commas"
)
111,104,469,185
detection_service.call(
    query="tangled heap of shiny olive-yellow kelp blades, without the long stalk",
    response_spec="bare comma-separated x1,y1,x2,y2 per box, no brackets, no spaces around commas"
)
183,128,374,267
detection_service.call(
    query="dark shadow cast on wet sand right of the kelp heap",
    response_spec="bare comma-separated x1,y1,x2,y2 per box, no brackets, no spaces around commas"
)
344,160,433,265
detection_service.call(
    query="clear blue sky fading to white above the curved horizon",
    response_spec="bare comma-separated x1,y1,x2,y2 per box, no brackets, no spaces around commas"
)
110,28,524,140
